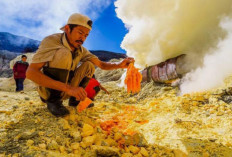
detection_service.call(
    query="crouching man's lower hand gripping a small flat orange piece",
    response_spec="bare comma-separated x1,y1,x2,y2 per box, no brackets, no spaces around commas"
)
66,86,87,101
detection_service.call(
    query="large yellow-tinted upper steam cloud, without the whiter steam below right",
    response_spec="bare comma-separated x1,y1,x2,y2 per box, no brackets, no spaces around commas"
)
115,0,232,66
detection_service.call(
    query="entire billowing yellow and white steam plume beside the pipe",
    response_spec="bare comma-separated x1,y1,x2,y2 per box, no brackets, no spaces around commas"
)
115,0,232,93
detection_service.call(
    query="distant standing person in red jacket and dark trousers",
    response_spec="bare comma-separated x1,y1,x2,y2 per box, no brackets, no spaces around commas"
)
13,55,29,92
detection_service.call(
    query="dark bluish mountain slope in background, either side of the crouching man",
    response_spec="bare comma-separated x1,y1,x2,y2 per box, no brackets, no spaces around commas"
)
0,32,126,77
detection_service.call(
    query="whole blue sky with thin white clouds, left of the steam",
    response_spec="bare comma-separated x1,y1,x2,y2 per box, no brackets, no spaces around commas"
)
0,0,128,53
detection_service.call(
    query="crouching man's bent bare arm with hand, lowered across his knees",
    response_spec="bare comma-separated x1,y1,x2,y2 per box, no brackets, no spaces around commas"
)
26,63,87,100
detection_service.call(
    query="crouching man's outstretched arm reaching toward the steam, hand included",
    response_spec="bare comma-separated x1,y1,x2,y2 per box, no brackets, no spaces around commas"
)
90,57,134,70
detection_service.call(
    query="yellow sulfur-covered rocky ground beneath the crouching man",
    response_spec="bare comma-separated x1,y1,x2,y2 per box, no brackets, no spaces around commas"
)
0,72,232,157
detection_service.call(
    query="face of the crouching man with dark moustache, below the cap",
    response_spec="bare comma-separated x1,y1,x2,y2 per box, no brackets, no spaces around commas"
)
65,26,90,48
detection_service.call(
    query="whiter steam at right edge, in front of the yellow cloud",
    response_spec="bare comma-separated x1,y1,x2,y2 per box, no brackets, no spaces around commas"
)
180,19,232,94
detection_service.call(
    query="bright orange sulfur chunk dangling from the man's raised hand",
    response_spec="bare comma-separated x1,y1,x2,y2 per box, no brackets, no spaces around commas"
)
124,63,142,93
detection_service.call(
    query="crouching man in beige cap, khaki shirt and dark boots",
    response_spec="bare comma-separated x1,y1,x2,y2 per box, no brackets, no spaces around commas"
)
27,13,134,117
